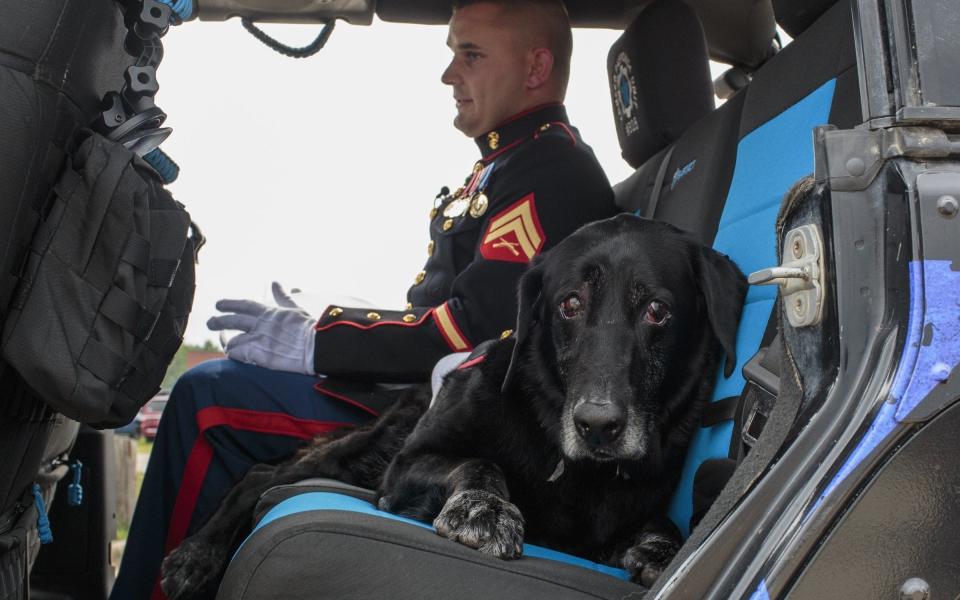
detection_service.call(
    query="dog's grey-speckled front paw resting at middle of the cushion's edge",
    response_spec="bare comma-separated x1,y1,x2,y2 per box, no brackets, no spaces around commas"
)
433,490,523,559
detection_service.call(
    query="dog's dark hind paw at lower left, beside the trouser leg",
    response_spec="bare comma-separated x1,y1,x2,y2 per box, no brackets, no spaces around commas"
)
160,537,227,600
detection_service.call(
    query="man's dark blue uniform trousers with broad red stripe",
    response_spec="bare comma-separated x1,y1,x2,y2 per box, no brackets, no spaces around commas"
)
110,360,371,600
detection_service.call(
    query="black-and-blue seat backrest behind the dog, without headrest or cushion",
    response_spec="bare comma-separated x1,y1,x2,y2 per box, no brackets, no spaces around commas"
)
653,0,860,535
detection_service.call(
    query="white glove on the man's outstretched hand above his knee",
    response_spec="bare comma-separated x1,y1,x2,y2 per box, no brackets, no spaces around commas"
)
207,282,317,375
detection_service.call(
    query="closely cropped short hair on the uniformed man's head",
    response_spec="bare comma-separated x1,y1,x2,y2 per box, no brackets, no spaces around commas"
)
453,0,573,92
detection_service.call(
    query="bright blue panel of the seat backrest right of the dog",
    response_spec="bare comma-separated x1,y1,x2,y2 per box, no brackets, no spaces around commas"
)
668,79,836,538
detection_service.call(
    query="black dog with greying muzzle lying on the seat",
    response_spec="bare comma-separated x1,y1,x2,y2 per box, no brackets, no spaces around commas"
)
163,215,746,600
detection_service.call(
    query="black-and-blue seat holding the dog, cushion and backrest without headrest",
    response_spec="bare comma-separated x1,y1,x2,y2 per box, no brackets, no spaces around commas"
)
218,0,859,598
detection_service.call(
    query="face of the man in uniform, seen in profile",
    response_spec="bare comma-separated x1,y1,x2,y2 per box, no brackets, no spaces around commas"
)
441,3,530,137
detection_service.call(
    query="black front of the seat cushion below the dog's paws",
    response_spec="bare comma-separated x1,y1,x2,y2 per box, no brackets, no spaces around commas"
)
217,500,644,600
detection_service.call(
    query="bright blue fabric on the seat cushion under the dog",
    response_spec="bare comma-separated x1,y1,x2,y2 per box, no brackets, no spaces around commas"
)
244,492,630,580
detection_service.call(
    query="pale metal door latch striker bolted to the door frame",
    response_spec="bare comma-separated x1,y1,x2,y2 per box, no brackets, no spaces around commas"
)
747,223,826,327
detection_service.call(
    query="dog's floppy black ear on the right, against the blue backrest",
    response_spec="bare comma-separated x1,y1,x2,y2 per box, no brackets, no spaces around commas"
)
699,248,747,377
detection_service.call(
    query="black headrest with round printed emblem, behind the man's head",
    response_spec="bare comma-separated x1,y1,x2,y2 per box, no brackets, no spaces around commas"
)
607,0,714,168
